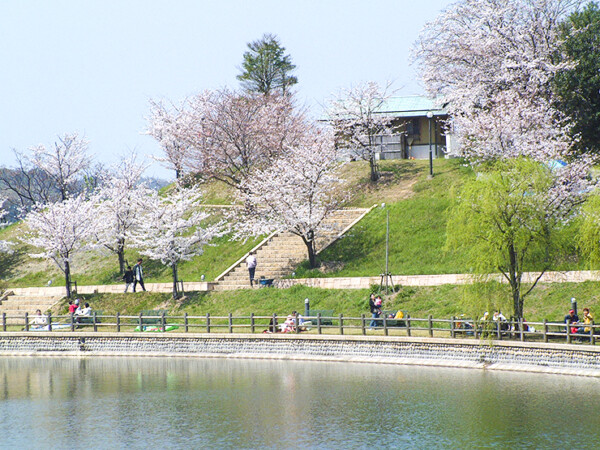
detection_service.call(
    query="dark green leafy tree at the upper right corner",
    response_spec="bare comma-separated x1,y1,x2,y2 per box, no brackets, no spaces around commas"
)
554,2,600,154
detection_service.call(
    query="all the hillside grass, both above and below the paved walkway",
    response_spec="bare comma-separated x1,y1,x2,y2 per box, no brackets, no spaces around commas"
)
0,156,600,320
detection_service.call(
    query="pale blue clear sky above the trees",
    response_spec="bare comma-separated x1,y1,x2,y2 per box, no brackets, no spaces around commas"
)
0,0,453,179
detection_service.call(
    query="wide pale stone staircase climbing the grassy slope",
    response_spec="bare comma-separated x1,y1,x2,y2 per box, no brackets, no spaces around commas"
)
214,208,372,291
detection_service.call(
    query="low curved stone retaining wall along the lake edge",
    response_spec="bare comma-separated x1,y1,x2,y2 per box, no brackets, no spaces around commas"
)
0,332,600,378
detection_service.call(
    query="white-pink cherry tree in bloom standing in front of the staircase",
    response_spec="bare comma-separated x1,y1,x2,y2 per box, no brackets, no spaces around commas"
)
233,132,345,267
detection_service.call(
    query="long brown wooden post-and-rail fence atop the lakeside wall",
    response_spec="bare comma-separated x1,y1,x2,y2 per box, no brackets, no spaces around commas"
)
1,311,600,345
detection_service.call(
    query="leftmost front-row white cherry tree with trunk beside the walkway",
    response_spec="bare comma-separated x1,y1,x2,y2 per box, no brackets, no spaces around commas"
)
21,194,101,298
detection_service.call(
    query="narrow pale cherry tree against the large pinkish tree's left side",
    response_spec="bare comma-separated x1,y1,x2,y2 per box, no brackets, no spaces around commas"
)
147,100,189,178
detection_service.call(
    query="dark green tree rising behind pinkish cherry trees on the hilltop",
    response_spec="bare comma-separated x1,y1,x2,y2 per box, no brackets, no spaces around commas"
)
237,34,298,94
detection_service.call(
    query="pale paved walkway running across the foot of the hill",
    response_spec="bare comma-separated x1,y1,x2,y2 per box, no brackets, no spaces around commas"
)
7,270,600,297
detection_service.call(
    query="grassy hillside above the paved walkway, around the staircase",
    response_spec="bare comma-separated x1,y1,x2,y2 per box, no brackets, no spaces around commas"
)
0,160,584,287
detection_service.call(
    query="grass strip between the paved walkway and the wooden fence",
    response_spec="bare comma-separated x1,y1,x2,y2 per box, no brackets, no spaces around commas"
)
54,282,600,322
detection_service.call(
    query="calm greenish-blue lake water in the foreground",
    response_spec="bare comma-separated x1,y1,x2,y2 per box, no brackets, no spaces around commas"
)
0,357,600,448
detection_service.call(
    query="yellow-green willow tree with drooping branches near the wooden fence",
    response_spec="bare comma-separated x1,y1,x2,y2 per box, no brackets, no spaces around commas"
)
447,158,574,317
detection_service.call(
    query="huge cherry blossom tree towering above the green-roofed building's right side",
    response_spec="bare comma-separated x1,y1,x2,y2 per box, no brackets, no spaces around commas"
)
413,0,580,115
